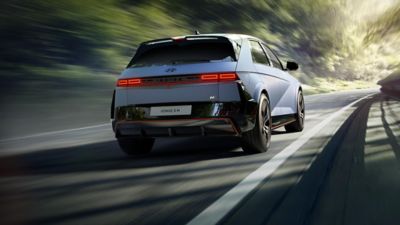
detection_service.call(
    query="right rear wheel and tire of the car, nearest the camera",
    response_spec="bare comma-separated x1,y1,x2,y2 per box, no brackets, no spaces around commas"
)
242,94,272,154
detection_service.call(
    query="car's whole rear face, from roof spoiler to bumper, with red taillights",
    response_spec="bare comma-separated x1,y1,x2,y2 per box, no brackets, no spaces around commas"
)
112,35,252,144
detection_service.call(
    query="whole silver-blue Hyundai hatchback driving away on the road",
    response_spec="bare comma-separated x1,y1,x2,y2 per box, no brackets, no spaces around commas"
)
111,34,305,155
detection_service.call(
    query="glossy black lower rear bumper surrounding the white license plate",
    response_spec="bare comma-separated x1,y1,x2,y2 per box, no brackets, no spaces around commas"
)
113,102,256,137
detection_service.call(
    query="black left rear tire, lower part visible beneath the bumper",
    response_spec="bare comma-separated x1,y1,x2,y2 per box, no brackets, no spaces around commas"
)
118,138,154,155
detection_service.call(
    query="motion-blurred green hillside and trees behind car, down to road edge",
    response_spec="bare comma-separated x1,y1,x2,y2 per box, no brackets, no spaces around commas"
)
0,0,400,138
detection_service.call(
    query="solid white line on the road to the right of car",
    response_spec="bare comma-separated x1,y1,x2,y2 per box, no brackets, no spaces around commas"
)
187,93,375,225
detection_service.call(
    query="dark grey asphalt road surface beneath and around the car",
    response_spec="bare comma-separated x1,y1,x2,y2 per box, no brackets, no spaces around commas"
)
0,90,400,225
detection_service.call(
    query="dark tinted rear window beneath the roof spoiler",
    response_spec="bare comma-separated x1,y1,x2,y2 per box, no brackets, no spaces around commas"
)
128,38,236,67
